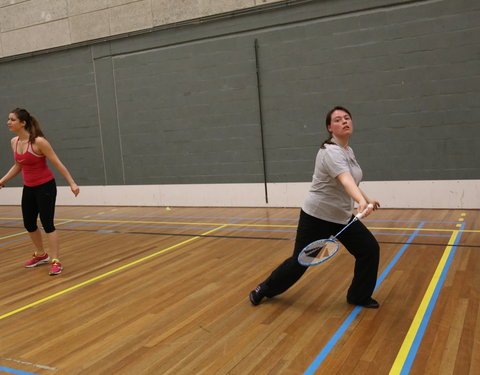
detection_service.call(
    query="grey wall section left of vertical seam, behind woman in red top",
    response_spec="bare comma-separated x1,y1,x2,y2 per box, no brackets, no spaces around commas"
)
0,47,104,186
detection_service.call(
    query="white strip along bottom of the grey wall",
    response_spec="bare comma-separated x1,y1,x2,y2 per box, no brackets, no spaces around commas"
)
0,180,480,209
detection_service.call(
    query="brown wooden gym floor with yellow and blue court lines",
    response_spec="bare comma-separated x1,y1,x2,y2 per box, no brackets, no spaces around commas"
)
0,206,480,375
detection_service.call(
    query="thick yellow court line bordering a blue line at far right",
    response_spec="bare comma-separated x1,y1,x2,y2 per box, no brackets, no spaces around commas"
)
389,230,461,375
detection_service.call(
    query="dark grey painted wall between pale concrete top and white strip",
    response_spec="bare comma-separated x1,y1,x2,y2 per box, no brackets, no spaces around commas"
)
0,0,480,185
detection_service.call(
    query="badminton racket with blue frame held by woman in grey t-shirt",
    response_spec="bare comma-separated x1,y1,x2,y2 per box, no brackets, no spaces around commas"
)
298,204,373,266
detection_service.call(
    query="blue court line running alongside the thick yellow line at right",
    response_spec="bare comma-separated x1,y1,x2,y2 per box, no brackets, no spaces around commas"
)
400,223,465,375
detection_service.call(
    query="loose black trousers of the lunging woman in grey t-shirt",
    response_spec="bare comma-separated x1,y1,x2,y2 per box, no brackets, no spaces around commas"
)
261,210,380,304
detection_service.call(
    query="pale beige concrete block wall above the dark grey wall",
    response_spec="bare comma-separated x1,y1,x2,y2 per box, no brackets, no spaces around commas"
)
0,0,283,58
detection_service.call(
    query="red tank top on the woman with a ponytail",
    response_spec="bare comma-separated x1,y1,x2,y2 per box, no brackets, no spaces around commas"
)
14,138,55,187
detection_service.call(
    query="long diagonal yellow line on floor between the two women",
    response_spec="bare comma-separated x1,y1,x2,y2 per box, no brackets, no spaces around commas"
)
0,225,228,320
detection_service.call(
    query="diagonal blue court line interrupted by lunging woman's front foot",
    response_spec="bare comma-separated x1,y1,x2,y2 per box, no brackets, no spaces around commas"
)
304,221,425,375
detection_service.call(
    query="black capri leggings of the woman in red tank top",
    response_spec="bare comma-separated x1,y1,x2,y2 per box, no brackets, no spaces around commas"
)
22,179,57,233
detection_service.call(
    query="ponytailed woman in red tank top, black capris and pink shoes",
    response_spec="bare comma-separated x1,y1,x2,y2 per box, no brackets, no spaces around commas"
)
0,108,80,275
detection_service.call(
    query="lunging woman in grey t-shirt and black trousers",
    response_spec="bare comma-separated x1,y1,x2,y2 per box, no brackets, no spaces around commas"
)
249,107,380,308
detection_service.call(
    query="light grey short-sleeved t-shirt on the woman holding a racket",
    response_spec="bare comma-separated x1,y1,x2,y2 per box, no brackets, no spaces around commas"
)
302,140,362,224
